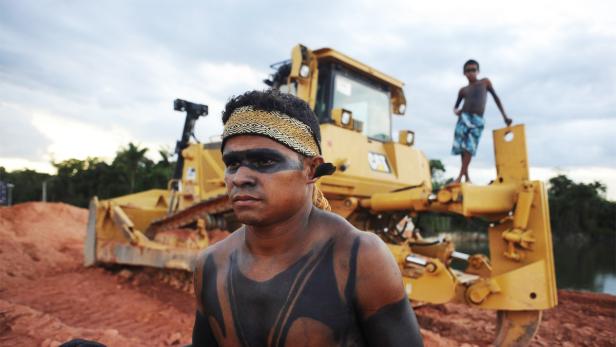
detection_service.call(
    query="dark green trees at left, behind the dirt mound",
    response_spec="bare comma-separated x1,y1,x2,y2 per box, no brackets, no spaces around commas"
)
0,143,175,207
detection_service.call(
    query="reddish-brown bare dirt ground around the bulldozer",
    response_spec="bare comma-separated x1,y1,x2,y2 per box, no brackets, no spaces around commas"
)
0,203,616,346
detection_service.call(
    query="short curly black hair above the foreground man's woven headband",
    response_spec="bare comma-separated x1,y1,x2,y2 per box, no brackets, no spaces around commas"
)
222,89,321,147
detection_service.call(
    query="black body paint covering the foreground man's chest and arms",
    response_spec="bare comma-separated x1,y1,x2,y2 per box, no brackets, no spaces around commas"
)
193,238,423,347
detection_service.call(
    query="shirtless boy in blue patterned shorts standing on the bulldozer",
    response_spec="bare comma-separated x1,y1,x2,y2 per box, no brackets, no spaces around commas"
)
451,59,513,183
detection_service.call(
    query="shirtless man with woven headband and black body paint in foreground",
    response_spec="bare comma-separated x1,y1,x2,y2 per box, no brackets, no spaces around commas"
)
193,91,423,347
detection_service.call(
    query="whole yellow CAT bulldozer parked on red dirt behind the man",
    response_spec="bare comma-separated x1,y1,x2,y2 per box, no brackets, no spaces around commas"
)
85,45,557,346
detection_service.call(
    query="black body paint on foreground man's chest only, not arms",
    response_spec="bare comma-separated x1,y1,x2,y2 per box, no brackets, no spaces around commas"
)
227,240,364,347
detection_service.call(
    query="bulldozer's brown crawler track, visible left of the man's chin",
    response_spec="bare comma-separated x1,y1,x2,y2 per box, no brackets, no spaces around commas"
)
145,194,231,237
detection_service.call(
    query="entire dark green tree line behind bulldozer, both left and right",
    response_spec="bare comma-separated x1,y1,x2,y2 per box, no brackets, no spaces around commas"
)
0,151,616,236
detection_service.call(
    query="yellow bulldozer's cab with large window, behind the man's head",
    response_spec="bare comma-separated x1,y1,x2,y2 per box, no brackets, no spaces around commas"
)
266,45,406,142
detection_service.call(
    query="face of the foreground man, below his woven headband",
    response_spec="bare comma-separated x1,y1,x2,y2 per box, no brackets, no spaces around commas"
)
222,135,312,226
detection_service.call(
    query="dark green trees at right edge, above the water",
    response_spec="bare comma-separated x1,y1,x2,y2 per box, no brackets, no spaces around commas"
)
548,175,616,236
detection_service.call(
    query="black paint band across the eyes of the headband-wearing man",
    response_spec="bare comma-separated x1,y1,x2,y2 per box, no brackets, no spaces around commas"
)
222,148,304,174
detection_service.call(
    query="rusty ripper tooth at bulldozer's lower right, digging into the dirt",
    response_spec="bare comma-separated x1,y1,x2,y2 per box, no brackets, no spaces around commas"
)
494,310,542,347
